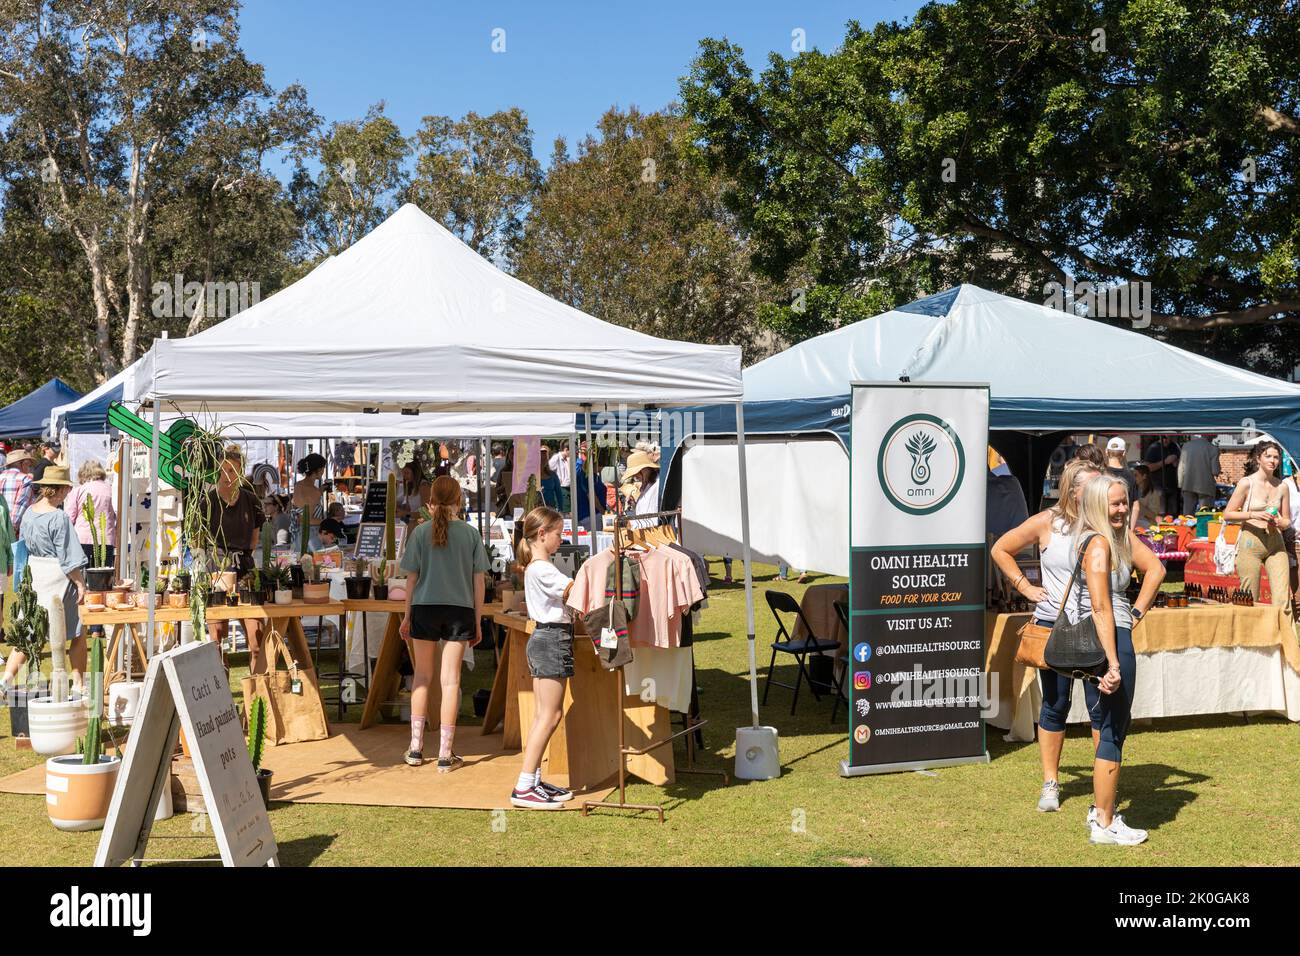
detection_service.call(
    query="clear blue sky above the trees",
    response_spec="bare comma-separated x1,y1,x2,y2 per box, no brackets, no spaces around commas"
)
241,0,920,163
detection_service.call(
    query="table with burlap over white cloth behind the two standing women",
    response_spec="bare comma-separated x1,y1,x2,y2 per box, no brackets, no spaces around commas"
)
984,604,1300,740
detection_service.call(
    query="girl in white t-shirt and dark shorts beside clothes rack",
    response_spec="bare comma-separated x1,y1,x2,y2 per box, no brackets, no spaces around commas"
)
510,507,573,810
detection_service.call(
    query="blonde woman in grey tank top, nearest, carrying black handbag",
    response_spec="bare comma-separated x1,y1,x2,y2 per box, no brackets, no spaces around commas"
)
1065,475,1165,847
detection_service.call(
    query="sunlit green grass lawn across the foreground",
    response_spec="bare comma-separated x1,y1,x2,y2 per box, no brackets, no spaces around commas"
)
0,563,1300,866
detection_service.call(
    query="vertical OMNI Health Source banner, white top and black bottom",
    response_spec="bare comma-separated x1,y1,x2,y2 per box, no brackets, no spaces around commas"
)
840,382,988,777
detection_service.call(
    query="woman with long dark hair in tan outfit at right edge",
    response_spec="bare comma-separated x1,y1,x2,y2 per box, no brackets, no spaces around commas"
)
1223,441,1294,607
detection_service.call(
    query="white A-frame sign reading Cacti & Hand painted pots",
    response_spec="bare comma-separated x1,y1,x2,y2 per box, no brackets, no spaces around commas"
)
95,641,278,866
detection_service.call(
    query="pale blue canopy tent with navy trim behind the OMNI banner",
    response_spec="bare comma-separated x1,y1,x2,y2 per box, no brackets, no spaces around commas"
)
662,285,1300,572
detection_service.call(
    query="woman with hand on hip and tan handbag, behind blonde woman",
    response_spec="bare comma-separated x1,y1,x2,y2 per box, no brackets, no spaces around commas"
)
989,458,1101,813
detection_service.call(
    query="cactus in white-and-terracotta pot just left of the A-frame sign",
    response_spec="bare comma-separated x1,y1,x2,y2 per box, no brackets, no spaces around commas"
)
46,636,122,830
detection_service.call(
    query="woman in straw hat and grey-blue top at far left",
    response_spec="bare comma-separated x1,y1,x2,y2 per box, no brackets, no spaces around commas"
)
0,464,86,697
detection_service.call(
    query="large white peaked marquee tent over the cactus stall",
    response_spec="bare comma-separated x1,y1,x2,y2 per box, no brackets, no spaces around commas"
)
124,204,758,727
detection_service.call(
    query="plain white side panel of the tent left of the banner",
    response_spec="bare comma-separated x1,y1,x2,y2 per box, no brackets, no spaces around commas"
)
681,437,849,578
